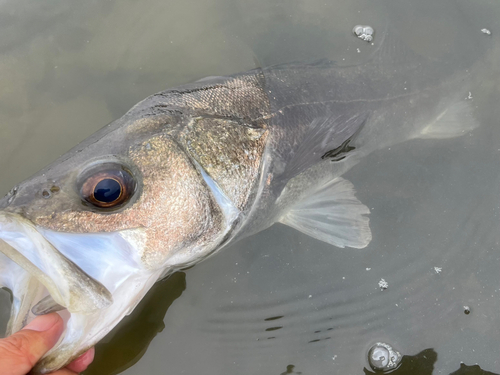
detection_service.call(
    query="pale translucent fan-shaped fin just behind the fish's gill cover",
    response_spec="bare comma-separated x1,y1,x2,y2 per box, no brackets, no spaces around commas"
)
279,177,372,249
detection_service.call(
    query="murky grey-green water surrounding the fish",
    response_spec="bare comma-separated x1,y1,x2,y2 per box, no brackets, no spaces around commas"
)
0,0,500,375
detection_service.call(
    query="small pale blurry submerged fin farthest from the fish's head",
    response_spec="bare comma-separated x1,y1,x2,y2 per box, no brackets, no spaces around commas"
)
416,100,479,139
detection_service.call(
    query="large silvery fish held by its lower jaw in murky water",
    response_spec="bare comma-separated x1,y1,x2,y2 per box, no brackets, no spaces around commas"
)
0,32,488,374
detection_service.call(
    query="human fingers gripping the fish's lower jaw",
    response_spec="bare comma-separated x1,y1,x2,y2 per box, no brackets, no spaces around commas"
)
0,313,94,375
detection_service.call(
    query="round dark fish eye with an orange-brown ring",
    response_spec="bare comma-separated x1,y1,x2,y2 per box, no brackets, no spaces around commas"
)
80,166,136,208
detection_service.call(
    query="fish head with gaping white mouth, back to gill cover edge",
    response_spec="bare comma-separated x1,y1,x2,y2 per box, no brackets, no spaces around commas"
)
0,100,238,373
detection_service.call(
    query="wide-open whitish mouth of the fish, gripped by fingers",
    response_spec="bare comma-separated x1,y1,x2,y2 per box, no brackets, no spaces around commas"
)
0,211,162,374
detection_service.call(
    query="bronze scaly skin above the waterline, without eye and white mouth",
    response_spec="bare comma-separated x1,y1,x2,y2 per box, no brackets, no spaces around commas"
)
0,74,274,265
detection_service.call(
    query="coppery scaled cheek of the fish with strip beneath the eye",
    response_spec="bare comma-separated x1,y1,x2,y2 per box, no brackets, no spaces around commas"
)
32,135,223,269
